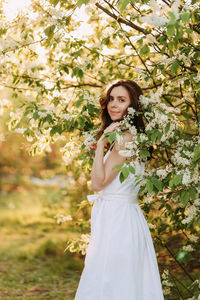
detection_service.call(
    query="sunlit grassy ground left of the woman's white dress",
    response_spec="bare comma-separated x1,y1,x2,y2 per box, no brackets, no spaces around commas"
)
0,183,83,300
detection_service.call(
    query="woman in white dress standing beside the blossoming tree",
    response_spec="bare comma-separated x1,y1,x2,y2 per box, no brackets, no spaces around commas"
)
75,80,164,300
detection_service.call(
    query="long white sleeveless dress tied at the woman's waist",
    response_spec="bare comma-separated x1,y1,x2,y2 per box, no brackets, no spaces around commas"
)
75,144,164,300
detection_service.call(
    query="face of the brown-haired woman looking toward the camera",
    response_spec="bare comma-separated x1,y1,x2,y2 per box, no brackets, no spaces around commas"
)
107,85,131,122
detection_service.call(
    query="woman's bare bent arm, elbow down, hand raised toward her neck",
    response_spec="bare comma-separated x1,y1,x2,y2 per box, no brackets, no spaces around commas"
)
91,131,133,192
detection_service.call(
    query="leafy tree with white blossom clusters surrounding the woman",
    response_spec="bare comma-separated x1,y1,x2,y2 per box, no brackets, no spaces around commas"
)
0,0,200,299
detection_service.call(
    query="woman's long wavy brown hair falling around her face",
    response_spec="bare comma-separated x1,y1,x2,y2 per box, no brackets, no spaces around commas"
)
97,79,153,157
